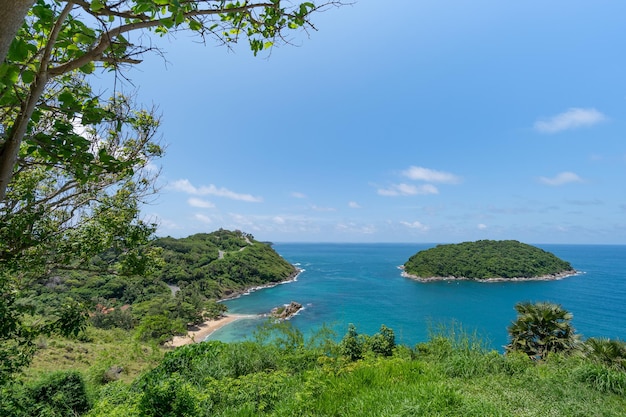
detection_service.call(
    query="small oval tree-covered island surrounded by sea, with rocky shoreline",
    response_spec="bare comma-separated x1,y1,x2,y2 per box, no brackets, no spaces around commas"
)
401,240,576,282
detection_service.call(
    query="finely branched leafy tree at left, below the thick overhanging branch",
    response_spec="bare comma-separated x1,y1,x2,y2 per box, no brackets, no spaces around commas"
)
0,84,161,385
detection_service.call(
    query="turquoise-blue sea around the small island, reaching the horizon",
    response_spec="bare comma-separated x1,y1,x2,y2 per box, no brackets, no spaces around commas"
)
209,243,626,350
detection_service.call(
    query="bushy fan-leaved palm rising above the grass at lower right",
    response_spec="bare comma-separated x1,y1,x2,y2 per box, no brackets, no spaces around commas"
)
506,302,579,360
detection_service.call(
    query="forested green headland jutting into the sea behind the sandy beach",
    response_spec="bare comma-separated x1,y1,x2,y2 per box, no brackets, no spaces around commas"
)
78,229,296,334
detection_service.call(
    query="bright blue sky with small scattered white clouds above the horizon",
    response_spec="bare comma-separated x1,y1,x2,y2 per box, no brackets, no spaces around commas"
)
106,0,626,244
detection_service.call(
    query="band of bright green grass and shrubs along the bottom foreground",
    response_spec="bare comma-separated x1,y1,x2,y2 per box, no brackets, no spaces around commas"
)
0,316,626,417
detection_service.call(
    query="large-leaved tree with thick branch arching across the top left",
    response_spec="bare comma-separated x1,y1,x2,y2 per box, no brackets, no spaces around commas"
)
0,0,338,202
